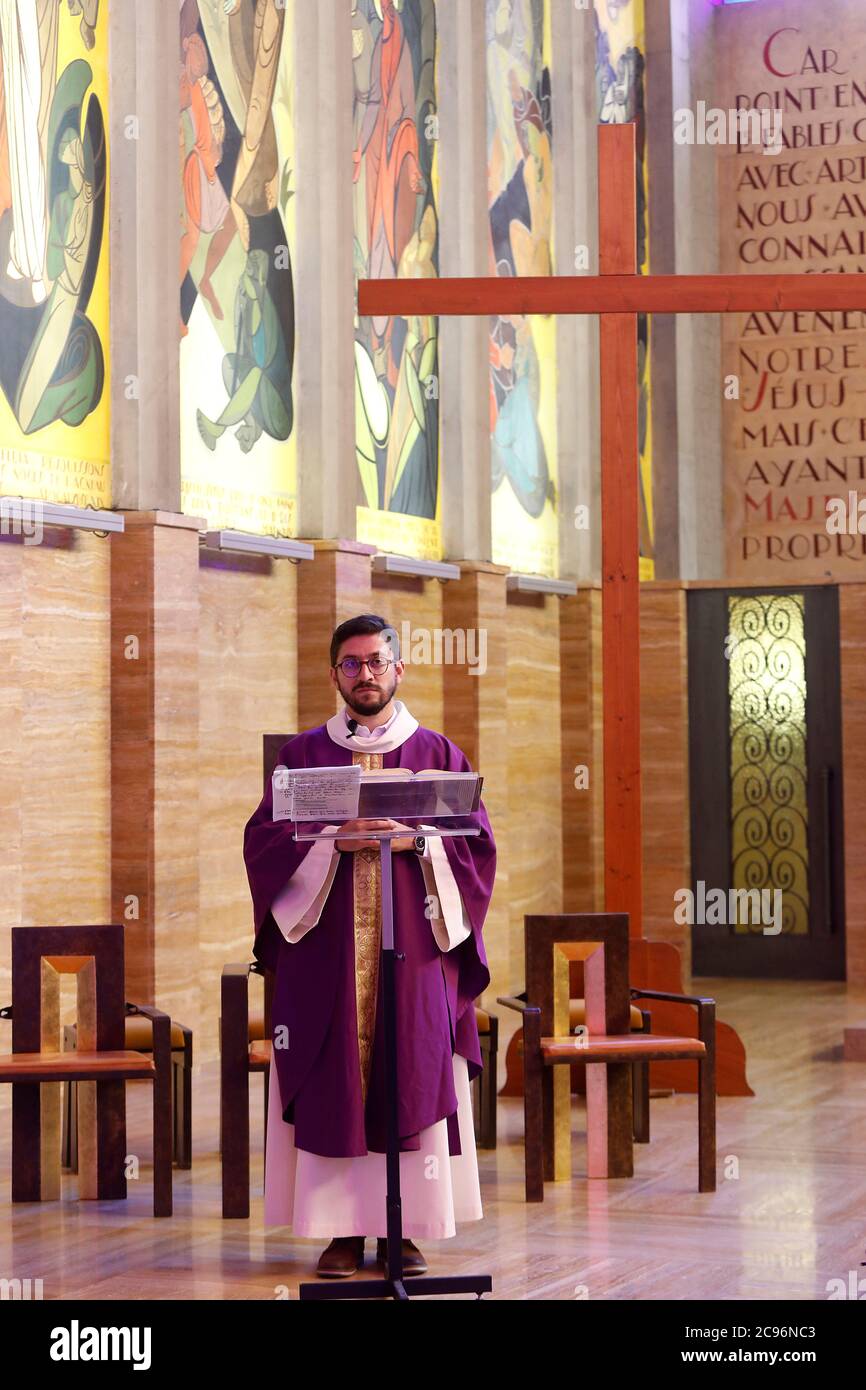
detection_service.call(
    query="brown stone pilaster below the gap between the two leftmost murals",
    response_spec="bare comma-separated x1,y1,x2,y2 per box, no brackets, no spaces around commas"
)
111,512,200,1029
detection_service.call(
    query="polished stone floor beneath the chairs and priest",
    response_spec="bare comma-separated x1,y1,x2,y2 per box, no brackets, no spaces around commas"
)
0,980,866,1301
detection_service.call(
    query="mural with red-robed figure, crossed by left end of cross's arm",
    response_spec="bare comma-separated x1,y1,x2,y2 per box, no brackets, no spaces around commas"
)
350,0,442,559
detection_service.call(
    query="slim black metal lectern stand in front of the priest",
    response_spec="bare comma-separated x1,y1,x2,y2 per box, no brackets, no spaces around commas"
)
295,828,493,1302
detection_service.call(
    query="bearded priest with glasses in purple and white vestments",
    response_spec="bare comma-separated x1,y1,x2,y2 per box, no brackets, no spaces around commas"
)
245,614,496,1277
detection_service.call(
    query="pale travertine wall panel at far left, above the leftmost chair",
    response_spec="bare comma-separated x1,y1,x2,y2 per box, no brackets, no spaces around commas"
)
0,532,111,1011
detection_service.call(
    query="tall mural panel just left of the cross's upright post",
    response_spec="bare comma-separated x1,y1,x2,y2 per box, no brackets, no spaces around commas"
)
485,0,559,577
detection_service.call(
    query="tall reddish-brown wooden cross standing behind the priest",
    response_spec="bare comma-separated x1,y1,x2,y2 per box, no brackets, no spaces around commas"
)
359,125,866,937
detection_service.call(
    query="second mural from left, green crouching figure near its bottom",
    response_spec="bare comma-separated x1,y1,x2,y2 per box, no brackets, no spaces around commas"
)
179,0,297,535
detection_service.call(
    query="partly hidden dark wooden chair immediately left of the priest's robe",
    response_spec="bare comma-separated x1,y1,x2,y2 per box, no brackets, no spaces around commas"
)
220,962,274,1219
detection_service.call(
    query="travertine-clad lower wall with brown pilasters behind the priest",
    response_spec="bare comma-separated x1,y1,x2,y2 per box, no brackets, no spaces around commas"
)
6,556,866,1061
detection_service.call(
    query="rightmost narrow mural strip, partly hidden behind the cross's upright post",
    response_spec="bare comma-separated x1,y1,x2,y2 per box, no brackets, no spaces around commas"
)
595,0,655,580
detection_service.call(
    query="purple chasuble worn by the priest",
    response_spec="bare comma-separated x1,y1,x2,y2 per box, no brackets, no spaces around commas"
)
243,724,496,1158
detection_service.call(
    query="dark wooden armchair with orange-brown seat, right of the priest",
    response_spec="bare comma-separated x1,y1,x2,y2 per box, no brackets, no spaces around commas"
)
499,913,716,1202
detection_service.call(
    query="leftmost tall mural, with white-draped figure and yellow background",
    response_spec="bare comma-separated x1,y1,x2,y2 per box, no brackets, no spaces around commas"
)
0,0,111,507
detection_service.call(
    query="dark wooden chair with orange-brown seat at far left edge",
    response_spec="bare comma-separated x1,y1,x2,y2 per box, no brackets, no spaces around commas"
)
0,926,171,1216
